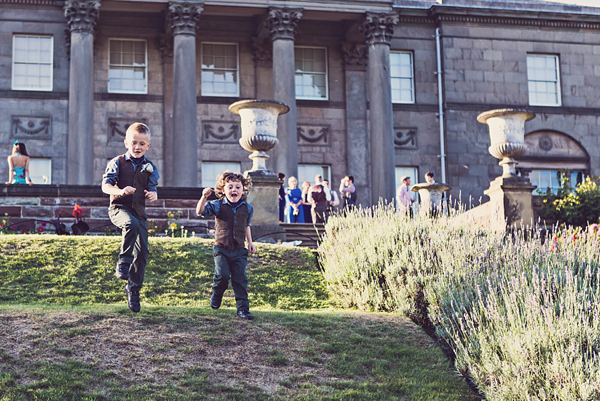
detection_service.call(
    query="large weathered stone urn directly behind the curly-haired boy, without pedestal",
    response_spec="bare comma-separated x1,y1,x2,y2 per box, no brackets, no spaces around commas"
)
229,100,290,173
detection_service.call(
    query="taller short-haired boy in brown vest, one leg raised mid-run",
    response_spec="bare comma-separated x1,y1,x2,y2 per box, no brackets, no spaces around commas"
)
102,123,159,312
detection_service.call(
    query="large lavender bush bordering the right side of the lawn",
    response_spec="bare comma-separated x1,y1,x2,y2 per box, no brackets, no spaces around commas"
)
319,205,600,401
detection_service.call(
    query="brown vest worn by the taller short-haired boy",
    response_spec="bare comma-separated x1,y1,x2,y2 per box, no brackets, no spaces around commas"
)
110,155,150,218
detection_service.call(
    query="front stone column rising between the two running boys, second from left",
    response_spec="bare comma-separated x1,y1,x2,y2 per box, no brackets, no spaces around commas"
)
168,2,203,187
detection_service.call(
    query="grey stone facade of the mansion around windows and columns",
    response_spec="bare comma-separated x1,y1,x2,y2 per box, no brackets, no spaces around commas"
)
0,0,600,205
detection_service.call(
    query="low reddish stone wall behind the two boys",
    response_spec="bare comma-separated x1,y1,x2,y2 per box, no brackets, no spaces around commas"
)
0,185,214,235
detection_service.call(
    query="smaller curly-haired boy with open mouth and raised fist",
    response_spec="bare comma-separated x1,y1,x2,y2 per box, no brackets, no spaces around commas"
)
196,171,256,320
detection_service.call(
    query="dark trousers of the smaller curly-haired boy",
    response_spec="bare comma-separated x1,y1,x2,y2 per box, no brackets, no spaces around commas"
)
213,245,250,311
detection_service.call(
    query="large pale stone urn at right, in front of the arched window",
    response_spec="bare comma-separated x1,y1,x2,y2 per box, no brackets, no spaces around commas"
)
477,109,535,177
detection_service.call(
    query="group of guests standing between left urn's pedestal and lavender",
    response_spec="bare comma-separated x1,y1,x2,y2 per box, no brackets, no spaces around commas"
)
277,173,357,223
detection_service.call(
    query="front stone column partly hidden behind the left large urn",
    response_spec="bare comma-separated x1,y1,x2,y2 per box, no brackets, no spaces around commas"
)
267,8,302,177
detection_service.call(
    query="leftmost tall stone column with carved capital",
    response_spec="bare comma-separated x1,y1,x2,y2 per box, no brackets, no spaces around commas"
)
64,0,100,185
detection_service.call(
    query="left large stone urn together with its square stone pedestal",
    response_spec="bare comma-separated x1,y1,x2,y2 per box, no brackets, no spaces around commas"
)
229,100,289,242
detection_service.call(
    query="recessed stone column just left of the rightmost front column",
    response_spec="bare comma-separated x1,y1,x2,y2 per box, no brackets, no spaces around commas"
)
342,43,371,206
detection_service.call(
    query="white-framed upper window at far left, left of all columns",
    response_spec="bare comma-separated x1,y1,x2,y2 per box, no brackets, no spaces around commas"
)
12,35,54,91
